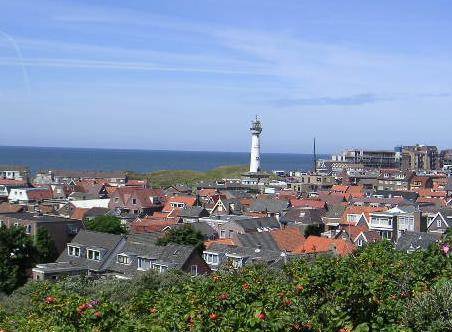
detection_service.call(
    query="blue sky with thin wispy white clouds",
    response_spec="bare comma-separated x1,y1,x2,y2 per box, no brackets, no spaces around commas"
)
0,0,452,153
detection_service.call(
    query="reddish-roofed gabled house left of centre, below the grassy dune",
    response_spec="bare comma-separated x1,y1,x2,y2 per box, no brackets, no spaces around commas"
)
108,187,164,219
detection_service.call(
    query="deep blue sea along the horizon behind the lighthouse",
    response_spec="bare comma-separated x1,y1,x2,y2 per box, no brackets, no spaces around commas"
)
0,146,329,173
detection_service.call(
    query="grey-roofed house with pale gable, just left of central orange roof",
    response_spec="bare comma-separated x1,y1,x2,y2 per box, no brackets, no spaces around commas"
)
218,217,281,239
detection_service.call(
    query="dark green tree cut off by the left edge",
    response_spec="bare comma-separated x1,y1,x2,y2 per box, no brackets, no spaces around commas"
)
0,226,36,294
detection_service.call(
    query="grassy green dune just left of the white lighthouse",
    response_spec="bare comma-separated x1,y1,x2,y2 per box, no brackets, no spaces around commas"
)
129,166,248,187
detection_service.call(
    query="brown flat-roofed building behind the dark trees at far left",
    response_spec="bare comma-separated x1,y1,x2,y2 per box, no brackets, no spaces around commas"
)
0,212,84,252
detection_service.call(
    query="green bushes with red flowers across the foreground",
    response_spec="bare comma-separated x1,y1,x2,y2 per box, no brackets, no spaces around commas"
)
0,237,452,332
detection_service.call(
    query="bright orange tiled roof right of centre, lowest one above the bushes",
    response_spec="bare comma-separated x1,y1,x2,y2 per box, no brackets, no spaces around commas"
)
297,236,356,256
